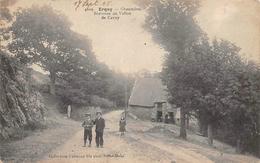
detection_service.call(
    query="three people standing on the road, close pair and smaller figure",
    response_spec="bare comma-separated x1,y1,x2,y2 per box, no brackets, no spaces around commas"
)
82,111,126,148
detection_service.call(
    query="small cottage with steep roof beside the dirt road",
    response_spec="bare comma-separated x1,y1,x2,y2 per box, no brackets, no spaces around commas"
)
128,77,177,123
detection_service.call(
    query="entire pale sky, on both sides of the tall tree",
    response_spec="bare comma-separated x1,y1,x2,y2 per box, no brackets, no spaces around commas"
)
5,0,260,73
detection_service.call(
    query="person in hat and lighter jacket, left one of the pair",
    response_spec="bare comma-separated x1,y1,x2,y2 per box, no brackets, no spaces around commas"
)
82,113,93,147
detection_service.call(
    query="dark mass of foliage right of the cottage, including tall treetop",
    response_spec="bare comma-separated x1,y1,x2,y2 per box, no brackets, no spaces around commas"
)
145,0,260,153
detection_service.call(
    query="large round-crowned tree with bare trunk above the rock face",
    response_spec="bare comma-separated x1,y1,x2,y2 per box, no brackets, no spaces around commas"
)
8,6,92,94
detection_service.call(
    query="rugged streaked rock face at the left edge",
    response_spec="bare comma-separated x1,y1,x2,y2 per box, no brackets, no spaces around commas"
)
0,51,44,139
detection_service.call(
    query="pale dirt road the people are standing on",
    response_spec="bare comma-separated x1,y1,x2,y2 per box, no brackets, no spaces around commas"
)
40,111,260,163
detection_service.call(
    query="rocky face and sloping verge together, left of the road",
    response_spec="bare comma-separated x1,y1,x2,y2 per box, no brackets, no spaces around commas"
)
0,51,78,162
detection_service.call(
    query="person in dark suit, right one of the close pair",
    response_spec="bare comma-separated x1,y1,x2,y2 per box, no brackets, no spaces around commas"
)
94,111,105,148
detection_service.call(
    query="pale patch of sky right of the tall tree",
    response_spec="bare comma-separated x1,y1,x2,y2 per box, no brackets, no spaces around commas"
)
197,0,260,63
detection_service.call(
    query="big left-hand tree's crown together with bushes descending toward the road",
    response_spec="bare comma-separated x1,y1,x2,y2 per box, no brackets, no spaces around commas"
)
8,6,134,109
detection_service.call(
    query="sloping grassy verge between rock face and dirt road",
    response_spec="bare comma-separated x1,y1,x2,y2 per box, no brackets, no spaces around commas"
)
0,94,80,163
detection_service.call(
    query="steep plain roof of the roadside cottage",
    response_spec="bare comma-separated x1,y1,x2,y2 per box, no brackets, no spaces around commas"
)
129,77,167,107
